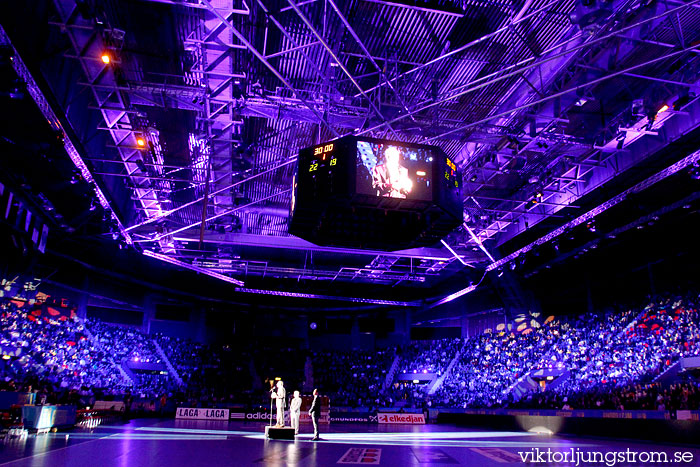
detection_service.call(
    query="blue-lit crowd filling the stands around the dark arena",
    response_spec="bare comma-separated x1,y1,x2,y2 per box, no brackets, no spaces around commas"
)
0,295,700,410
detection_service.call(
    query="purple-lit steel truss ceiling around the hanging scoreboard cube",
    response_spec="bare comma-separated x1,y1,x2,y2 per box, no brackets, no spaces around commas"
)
9,0,700,298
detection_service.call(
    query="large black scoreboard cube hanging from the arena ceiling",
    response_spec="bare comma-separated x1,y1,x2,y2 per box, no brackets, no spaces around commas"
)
289,136,463,250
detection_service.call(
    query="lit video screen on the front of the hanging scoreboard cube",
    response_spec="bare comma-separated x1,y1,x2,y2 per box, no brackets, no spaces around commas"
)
355,141,436,201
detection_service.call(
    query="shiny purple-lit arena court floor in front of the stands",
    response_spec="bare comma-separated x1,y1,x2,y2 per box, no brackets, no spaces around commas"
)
0,419,700,467
